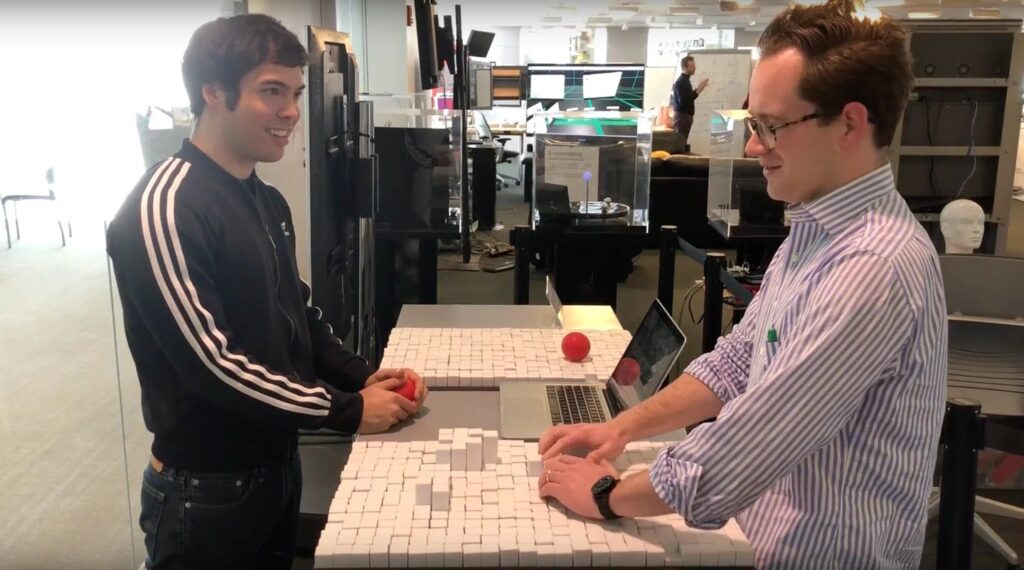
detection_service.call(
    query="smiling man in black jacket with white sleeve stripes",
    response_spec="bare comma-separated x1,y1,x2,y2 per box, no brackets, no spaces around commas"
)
108,14,426,569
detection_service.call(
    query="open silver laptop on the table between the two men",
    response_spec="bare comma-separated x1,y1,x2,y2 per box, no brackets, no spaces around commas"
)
499,299,686,440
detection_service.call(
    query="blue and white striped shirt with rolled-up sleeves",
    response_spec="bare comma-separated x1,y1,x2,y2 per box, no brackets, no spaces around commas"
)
650,165,947,569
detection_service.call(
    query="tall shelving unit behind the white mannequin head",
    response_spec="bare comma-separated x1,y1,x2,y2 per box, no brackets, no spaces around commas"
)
890,19,1024,255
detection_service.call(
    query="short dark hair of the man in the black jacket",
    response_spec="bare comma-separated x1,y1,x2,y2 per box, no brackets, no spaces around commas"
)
181,14,308,117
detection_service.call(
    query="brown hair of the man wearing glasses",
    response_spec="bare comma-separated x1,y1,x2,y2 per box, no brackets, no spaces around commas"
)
758,0,913,147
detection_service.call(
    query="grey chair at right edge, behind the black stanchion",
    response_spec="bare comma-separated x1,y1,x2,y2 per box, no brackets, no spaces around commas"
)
928,255,1024,567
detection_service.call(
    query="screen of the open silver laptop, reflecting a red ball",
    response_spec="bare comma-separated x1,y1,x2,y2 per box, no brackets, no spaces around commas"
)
608,299,686,407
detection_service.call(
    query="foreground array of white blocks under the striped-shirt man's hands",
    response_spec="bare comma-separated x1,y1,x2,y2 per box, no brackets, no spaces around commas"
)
315,430,754,568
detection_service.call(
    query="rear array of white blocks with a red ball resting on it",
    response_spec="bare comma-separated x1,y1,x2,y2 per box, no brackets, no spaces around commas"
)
381,327,632,388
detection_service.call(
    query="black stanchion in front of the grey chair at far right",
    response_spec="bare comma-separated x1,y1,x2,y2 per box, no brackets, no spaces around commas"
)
936,398,985,570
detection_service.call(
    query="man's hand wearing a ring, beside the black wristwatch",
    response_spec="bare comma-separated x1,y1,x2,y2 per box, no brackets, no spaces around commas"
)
538,455,618,520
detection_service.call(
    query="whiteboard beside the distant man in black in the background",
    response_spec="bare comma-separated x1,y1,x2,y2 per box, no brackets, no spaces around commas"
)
688,49,752,156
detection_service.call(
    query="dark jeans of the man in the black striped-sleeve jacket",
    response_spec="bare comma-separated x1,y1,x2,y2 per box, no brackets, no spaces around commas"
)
138,453,302,570
